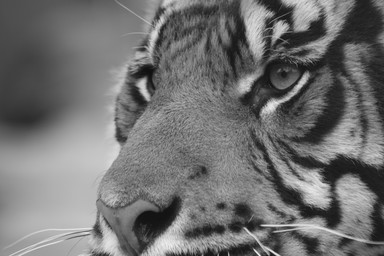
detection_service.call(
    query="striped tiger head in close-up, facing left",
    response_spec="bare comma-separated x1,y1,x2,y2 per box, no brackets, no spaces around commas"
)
89,0,384,256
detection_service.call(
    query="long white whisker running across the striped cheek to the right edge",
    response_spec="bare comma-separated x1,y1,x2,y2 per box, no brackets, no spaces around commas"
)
261,224,384,245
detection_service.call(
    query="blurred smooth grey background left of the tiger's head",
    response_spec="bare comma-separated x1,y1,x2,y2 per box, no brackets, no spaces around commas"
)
0,0,146,256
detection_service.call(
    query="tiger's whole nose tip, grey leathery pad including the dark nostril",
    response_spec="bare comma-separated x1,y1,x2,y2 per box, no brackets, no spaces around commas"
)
97,199,180,255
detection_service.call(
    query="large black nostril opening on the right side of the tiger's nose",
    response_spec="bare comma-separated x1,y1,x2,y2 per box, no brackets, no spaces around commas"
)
133,198,180,248
